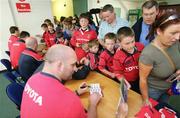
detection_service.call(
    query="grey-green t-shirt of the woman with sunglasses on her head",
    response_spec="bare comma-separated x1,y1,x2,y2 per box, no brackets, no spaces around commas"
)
139,41,180,90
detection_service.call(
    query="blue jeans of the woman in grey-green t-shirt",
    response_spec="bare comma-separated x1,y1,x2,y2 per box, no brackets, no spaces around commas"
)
148,87,169,103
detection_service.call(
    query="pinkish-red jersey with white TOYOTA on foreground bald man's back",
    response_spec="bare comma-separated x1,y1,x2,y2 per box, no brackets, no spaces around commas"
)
20,72,87,118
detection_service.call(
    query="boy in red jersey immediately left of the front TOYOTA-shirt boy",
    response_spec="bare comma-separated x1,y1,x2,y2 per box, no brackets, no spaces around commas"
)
98,33,116,78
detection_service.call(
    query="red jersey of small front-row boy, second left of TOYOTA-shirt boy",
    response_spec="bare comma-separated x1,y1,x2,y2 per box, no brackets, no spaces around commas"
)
87,52,99,70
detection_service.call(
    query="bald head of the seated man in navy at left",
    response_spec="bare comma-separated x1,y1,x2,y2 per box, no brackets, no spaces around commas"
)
26,37,38,50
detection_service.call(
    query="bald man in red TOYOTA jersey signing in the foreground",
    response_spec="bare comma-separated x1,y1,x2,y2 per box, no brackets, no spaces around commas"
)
21,44,100,118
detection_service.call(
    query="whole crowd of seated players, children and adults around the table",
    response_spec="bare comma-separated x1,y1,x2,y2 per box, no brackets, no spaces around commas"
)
8,0,180,118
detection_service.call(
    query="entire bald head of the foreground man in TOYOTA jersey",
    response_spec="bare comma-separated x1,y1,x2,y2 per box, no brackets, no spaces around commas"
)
43,44,77,80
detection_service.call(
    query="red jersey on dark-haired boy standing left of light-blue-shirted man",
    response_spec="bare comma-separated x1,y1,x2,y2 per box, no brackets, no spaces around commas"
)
70,28,97,47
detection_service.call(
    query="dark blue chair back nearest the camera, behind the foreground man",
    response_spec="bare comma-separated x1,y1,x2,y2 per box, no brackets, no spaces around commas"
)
6,83,24,110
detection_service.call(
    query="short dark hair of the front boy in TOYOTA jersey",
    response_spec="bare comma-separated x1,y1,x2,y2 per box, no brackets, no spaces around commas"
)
117,27,135,42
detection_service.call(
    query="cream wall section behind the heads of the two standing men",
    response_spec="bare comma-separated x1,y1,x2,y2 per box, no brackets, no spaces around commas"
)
88,0,139,19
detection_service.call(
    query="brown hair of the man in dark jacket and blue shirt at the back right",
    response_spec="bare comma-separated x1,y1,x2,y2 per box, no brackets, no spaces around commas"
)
142,0,159,10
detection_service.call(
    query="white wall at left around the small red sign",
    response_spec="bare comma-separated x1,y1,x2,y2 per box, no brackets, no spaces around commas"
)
0,0,53,70
